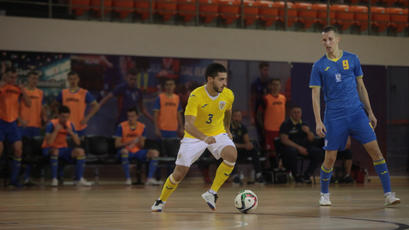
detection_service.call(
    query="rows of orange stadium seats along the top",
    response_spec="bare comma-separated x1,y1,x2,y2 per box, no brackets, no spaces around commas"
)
0,0,409,36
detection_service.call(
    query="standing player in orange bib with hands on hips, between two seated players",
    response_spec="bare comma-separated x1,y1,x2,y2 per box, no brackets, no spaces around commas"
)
57,71,99,137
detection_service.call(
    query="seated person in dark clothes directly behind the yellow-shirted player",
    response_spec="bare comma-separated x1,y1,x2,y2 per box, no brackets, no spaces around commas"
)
230,110,264,184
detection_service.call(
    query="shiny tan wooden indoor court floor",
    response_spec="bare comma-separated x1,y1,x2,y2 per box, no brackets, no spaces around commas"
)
0,180,409,230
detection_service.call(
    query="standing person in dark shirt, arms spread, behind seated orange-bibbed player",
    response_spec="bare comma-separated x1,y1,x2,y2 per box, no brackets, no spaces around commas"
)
100,69,154,123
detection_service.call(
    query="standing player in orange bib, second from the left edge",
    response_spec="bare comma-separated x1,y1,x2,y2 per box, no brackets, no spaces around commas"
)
18,71,47,185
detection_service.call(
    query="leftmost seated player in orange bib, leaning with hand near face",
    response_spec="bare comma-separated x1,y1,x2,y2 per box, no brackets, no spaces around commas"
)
42,106,92,186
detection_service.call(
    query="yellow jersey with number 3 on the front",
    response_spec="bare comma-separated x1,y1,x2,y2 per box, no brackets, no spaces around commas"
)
185,85,234,138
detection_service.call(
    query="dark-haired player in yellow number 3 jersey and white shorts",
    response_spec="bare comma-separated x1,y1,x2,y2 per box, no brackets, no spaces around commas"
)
152,63,237,212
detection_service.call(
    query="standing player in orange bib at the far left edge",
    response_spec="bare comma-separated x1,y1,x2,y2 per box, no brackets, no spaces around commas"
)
0,68,31,187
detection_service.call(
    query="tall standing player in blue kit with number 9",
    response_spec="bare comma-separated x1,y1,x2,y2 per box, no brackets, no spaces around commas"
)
310,26,400,206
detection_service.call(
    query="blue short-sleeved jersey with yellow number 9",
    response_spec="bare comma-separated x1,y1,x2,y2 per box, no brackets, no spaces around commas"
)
310,51,363,117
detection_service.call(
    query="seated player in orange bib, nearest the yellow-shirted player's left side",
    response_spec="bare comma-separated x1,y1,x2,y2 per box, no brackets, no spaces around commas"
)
115,107,161,185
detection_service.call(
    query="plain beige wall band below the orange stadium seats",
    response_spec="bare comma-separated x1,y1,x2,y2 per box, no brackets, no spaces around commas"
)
0,16,409,66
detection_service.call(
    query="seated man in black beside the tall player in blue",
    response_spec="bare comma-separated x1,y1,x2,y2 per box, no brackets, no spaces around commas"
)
280,106,324,184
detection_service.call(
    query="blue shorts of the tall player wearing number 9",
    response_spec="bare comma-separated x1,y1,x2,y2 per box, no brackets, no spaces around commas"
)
324,108,376,150
